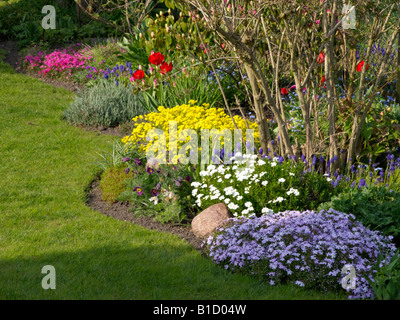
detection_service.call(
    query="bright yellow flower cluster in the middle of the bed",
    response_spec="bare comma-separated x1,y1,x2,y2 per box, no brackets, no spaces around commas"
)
122,100,259,156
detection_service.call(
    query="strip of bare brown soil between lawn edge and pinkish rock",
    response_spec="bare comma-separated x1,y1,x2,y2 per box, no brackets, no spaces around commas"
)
87,181,205,252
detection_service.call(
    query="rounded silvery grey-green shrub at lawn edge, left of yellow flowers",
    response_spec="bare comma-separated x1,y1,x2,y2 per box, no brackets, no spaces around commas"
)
64,80,144,127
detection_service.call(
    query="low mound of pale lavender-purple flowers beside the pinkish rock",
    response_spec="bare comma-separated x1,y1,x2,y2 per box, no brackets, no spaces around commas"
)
206,209,396,299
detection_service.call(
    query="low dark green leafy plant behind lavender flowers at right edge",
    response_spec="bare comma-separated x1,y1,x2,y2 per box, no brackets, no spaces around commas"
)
318,186,400,245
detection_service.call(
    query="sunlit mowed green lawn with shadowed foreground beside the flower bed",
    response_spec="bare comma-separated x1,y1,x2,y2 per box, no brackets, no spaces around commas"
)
0,55,343,299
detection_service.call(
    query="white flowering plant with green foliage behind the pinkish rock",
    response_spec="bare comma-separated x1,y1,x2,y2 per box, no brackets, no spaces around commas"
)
191,153,340,217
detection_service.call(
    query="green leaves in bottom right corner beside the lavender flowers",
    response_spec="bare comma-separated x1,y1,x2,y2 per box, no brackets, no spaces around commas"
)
367,251,400,300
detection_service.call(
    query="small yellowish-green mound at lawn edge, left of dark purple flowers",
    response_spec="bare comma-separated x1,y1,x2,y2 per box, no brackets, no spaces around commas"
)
99,167,132,203
